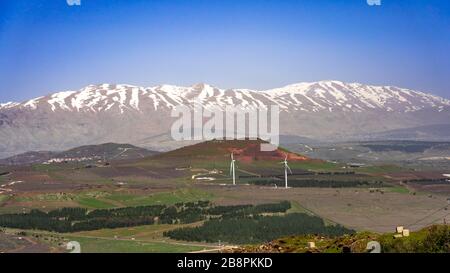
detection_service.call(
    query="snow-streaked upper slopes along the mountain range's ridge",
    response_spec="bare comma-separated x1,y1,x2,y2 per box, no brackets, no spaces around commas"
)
0,81,450,113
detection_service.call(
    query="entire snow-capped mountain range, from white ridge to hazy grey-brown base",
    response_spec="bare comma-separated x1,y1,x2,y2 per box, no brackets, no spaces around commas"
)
0,81,450,156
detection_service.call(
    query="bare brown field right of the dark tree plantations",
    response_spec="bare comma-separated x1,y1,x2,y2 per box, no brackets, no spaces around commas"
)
197,185,450,232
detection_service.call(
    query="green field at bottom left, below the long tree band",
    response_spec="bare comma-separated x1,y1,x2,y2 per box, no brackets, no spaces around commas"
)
0,225,217,253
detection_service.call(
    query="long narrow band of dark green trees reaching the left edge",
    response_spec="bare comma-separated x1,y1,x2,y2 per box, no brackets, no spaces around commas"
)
0,201,290,233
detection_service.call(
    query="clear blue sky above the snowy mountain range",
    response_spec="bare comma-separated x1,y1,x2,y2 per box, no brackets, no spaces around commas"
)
0,0,450,102
